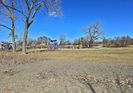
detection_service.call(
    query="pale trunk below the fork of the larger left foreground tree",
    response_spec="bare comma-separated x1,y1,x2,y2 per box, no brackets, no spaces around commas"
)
22,22,28,54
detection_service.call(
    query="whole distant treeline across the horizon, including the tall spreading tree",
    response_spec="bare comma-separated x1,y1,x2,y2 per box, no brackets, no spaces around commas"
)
16,22,133,48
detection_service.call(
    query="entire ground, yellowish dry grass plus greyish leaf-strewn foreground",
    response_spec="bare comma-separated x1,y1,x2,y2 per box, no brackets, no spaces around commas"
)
0,48,133,93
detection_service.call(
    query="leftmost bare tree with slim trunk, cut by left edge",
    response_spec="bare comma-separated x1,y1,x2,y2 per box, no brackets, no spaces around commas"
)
0,0,16,52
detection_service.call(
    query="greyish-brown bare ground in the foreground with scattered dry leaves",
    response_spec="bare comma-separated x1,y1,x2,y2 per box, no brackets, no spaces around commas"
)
0,59,133,93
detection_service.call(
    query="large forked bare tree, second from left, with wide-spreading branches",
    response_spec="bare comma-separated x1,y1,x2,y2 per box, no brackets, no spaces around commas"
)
0,0,61,54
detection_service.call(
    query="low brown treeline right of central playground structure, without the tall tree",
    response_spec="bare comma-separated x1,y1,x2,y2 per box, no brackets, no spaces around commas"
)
60,36,133,48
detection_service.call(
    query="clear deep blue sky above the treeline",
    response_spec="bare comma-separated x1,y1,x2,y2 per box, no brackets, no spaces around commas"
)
0,0,133,40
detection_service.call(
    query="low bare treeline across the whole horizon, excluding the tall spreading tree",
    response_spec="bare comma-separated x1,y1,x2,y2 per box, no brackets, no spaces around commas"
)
22,36,133,49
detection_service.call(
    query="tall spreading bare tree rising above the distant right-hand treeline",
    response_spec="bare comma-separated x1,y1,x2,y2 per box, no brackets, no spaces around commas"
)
83,22,103,48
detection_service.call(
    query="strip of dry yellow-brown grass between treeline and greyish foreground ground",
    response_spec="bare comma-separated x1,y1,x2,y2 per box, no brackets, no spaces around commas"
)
0,48,133,63
